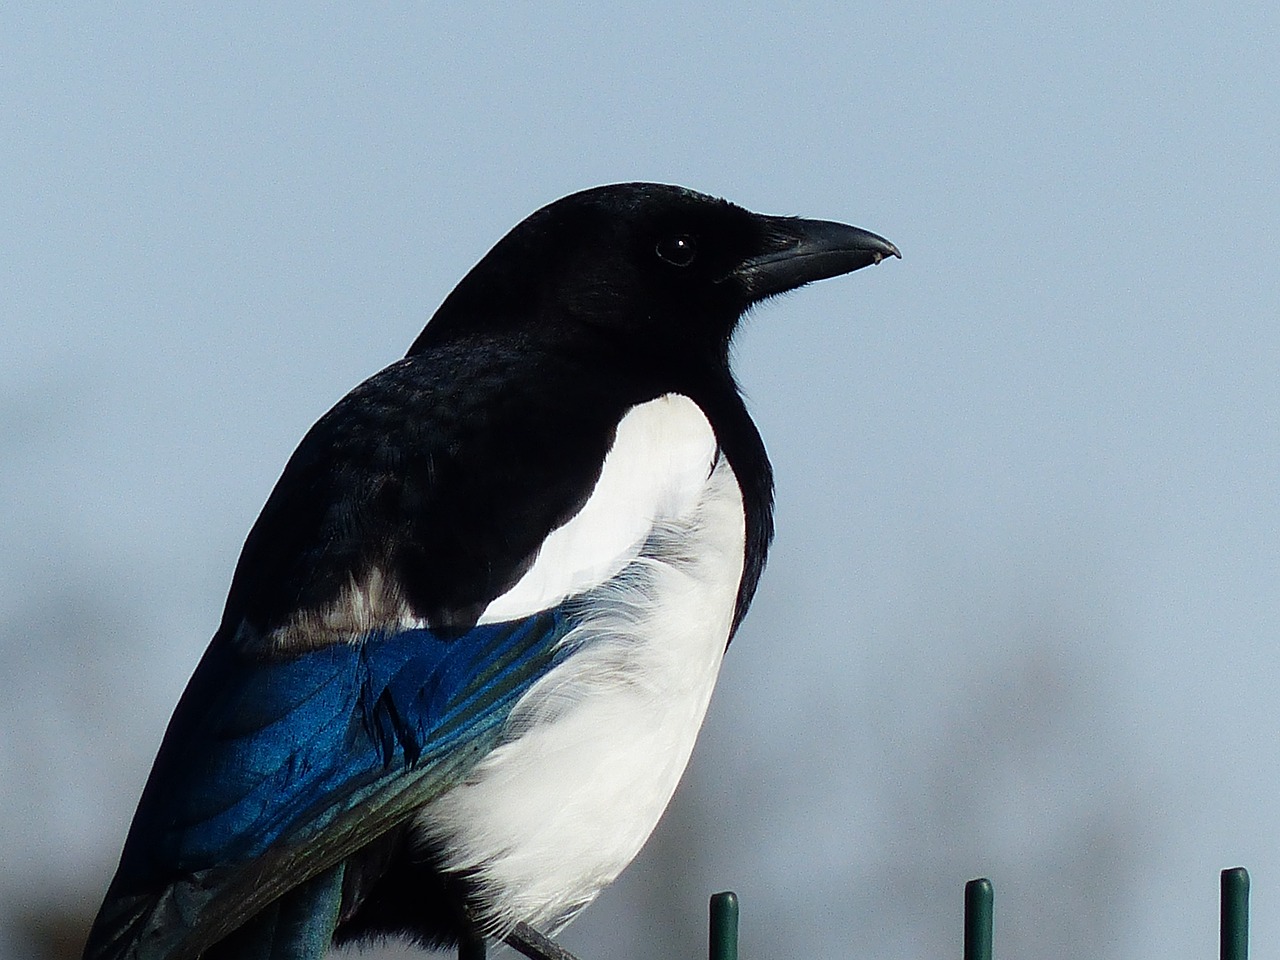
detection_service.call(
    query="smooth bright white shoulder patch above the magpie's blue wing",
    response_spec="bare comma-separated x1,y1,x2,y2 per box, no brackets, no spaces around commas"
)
480,393,716,623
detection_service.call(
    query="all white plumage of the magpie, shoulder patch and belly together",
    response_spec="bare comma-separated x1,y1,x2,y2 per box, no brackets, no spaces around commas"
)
416,396,745,933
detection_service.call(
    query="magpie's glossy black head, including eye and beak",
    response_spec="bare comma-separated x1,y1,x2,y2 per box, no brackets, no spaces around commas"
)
410,183,899,371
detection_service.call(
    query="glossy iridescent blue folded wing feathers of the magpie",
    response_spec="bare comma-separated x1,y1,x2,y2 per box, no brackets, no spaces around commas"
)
86,611,571,960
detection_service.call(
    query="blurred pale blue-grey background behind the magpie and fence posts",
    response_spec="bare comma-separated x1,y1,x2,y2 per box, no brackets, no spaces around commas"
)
0,0,1280,960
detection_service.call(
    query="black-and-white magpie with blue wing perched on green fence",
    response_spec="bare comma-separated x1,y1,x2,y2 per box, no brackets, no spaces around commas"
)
83,183,900,960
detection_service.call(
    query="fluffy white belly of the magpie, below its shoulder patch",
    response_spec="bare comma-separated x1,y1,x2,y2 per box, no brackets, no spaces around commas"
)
416,398,745,933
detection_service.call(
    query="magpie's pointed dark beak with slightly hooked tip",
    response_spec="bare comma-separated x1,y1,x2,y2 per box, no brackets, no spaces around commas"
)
732,216,902,301
